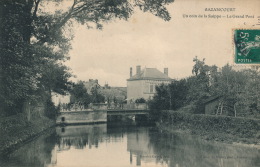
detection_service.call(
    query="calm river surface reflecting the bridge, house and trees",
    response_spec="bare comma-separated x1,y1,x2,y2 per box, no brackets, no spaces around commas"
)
0,124,260,167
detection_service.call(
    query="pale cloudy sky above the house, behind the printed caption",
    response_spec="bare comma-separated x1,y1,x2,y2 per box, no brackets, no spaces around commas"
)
66,0,260,86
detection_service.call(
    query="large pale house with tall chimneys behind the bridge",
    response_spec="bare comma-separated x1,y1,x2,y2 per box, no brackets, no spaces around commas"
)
127,66,172,103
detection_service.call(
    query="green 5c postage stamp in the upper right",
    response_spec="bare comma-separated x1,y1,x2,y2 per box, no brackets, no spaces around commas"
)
234,29,260,65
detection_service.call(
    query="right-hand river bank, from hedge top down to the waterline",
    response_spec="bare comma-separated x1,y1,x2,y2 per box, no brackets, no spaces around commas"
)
157,111,260,144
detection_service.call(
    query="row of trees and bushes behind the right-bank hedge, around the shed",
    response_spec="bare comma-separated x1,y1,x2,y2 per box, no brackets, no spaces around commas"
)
150,57,260,116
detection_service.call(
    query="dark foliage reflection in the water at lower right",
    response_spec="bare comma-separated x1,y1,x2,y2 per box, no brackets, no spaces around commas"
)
149,131,260,167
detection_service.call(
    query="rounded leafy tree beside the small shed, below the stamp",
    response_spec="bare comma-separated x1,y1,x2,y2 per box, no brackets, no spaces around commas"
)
210,64,254,116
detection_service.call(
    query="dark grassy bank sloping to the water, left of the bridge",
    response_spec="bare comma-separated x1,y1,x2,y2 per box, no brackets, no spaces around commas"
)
0,114,55,154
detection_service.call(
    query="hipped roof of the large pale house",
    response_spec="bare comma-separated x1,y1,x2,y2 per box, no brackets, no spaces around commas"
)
127,68,172,81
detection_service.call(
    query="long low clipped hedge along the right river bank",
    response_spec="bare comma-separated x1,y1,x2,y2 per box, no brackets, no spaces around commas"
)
157,110,260,138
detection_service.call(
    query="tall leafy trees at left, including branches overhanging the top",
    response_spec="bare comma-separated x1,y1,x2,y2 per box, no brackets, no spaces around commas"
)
0,0,173,115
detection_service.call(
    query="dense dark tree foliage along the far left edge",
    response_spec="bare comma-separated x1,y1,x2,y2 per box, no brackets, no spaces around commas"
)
0,1,37,113
